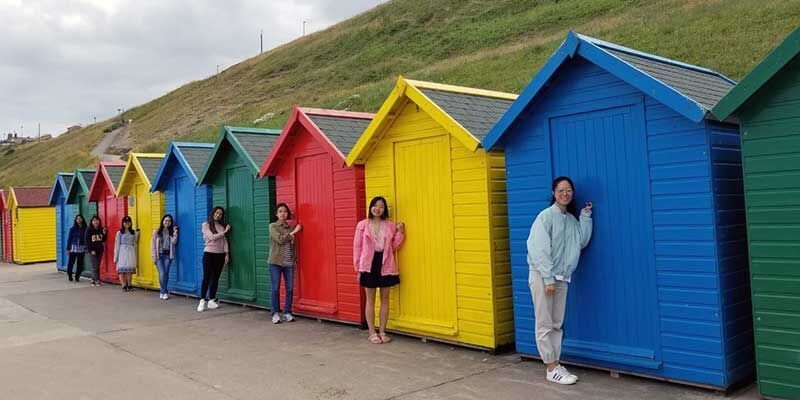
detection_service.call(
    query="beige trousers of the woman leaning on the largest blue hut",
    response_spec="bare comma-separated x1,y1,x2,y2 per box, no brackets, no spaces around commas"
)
528,271,569,364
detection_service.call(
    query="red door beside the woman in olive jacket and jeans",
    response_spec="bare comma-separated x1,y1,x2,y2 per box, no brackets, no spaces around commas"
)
295,153,337,316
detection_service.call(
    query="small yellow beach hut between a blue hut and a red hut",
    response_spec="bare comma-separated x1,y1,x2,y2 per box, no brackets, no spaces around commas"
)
117,153,164,289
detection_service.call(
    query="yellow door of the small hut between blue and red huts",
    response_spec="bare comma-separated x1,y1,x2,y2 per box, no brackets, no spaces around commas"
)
129,183,160,288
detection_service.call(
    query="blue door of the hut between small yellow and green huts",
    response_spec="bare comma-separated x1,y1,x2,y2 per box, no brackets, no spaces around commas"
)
171,174,196,293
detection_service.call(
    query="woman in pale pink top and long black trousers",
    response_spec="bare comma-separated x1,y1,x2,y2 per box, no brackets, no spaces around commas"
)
197,206,231,312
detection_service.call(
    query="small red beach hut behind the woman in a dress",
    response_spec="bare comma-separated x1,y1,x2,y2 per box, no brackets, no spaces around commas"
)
89,162,128,282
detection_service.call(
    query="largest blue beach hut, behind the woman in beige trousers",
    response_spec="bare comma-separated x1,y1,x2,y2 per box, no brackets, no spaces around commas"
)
482,32,753,389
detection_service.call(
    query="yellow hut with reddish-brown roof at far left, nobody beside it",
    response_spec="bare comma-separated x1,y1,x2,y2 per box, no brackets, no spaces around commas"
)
8,187,56,264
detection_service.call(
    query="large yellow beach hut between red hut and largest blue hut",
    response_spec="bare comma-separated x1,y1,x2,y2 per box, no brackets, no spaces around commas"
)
347,77,517,350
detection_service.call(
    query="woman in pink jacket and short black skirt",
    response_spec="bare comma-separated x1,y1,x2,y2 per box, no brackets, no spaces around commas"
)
353,197,405,344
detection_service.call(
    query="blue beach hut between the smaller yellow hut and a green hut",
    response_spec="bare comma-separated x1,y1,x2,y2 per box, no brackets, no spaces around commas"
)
148,142,214,296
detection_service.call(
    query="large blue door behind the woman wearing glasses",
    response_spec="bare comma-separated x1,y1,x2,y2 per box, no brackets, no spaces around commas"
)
549,99,661,369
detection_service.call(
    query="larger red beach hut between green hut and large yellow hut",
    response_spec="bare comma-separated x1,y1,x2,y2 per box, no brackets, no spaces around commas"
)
259,107,374,323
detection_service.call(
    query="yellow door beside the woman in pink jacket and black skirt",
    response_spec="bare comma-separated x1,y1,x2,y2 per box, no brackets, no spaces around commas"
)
389,135,458,336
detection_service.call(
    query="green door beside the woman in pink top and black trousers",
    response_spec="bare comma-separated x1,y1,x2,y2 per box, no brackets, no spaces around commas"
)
223,166,256,303
